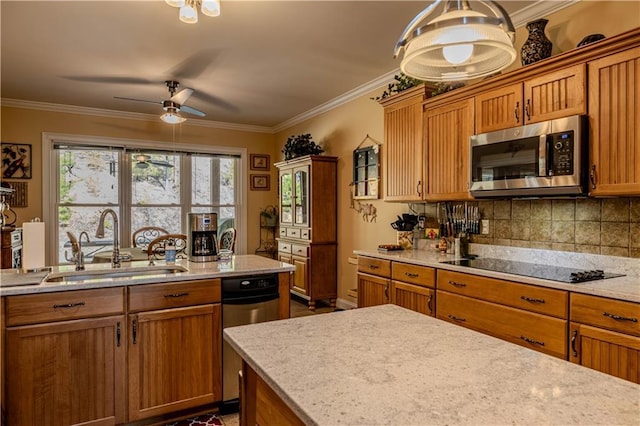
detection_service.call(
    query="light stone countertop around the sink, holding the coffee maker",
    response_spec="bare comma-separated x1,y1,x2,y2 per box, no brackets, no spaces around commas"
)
0,255,295,296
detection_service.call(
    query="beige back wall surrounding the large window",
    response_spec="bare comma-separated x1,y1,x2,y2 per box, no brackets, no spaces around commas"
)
1,107,277,253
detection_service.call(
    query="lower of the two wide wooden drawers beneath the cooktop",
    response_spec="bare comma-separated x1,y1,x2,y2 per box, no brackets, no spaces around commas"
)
436,290,568,359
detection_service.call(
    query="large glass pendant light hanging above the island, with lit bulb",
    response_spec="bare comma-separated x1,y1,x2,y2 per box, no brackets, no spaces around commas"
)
394,0,516,82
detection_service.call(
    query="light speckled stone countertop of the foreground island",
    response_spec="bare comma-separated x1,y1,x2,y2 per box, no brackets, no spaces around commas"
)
224,305,640,425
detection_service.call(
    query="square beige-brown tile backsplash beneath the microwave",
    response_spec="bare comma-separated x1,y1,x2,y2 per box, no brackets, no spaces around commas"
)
471,198,640,258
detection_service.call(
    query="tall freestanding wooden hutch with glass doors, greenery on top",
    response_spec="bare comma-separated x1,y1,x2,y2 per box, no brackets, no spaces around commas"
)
276,155,338,310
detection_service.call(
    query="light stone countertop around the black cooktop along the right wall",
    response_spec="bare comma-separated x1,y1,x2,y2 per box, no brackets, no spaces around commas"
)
354,244,640,303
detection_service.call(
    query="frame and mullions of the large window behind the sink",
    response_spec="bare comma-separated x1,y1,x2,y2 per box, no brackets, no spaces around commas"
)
42,132,248,265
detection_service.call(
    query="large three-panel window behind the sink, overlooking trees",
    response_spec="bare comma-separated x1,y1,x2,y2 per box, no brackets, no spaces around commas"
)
43,135,245,264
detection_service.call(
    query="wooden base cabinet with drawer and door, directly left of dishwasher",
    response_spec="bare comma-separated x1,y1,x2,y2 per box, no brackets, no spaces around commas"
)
127,279,222,421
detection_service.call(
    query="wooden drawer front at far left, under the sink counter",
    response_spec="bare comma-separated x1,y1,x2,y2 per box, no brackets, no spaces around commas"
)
6,287,124,326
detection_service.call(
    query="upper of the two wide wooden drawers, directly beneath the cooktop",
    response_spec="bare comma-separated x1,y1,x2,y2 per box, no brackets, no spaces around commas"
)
438,269,569,319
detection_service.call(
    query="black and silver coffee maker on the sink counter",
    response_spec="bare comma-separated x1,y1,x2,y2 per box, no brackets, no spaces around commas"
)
187,213,218,262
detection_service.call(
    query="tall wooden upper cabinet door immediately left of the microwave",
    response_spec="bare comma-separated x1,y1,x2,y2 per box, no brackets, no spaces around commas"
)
425,98,475,201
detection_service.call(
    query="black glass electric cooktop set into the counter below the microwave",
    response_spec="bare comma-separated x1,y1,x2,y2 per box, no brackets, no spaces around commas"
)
441,258,624,284
